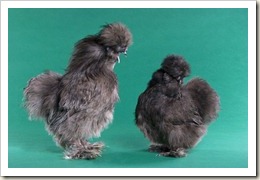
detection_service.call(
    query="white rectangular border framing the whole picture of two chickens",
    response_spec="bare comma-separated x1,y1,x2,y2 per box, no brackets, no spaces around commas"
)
1,1,256,176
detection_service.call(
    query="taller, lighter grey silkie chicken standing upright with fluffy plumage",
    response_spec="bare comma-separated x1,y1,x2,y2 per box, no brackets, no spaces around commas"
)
24,23,132,159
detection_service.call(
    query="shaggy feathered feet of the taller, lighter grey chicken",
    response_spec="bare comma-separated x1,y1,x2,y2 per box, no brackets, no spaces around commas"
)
64,141,104,160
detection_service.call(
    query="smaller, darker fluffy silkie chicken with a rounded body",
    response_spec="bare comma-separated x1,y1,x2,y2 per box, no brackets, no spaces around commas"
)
135,55,220,157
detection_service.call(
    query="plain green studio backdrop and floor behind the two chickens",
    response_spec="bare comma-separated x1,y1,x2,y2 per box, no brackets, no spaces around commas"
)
8,8,248,168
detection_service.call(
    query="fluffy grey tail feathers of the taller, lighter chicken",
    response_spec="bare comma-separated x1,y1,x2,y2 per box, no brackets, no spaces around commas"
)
23,71,61,119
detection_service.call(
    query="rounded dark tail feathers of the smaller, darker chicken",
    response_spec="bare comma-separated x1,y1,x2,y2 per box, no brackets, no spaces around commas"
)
186,78,220,124
